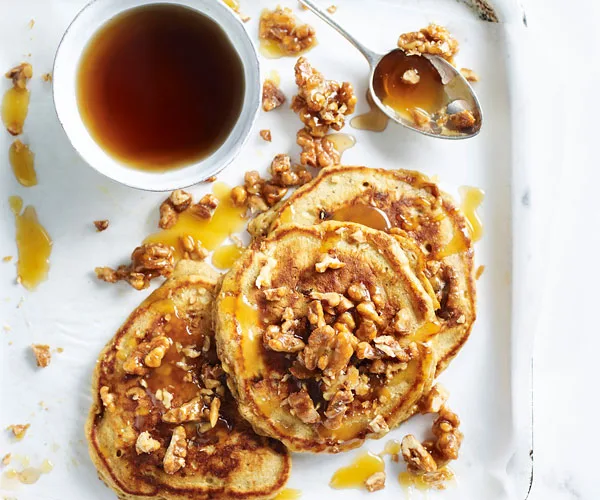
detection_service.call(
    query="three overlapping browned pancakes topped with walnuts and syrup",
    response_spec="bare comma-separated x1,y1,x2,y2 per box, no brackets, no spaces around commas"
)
86,166,475,499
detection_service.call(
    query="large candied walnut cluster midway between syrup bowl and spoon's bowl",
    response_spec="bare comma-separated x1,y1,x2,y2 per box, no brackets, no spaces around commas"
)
292,57,356,137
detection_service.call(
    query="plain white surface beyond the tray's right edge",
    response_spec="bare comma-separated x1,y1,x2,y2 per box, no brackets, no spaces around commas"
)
524,0,600,500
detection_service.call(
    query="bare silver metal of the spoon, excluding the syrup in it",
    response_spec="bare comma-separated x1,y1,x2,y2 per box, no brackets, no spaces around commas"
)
300,0,483,139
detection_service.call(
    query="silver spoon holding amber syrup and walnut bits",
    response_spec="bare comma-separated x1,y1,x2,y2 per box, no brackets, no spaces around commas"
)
300,0,483,139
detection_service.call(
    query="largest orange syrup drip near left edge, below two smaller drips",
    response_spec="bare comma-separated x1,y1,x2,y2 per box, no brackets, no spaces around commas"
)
9,196,52,290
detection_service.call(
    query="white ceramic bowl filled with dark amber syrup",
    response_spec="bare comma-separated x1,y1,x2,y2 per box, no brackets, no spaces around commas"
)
53,0,260,191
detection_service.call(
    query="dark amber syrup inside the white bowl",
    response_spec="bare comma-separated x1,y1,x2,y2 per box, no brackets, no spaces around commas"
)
77,4,245,171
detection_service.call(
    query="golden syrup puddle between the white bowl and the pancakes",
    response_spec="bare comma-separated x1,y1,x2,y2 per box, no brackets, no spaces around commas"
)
144,182,246,259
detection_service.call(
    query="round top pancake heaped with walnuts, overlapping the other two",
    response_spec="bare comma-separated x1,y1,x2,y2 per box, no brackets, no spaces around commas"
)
215,221,435,452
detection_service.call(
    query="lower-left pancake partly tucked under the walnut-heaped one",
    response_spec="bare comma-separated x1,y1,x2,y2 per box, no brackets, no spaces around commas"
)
86,261,291,500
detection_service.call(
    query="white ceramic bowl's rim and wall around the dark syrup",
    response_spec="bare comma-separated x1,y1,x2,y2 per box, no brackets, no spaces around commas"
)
53,0,261,191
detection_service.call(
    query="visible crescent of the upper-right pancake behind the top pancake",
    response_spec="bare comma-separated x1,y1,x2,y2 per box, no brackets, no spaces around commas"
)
249,166,475,373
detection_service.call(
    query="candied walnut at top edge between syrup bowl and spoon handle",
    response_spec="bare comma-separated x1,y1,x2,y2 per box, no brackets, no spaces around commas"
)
258,7,317,56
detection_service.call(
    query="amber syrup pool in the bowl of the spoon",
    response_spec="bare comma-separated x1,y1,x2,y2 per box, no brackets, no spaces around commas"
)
373,50,448,120
